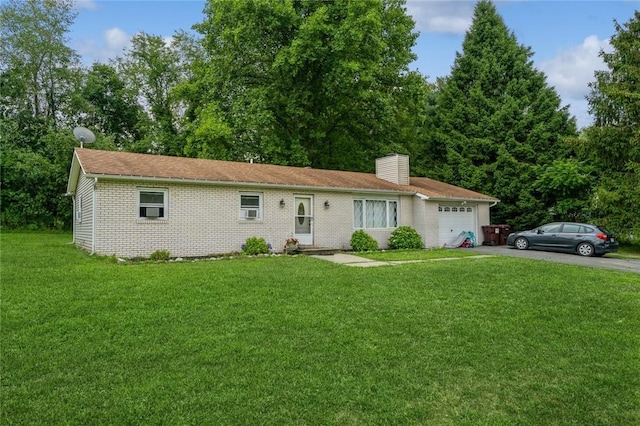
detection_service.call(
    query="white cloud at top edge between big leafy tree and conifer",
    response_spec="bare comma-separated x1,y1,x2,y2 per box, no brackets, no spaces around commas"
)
406,0,475,34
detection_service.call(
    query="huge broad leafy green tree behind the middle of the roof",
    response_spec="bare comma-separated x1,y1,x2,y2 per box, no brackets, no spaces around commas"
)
187,0,427,170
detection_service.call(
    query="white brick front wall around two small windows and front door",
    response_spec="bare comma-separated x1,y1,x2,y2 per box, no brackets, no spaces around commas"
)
89,180,388,257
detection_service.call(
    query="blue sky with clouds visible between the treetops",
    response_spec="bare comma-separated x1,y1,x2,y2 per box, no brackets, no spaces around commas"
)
69,0,640,127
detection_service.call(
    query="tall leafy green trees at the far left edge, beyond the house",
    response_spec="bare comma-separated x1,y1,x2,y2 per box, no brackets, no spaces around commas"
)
0,0,81,228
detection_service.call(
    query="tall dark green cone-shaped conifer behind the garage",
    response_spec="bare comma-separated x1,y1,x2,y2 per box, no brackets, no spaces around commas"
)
419,0,576,228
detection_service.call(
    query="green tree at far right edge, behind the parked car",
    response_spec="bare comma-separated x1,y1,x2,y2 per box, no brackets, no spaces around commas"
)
580,11,640,243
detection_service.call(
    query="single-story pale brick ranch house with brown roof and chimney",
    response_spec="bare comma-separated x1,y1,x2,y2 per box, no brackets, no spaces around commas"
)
67,148,498,257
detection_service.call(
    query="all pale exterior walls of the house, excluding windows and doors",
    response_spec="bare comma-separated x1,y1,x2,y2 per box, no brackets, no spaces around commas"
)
74,175,490,258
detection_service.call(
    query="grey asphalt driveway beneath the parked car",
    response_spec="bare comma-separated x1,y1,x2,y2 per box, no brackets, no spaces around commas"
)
470,246,640,274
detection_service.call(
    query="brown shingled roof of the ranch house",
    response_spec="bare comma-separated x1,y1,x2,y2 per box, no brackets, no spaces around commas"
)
68,148,498,201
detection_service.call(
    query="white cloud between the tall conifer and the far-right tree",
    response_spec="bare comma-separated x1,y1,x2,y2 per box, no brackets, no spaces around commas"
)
537,35,611,127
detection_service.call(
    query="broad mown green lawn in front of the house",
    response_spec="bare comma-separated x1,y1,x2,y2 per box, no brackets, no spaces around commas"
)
0,233,640,425
